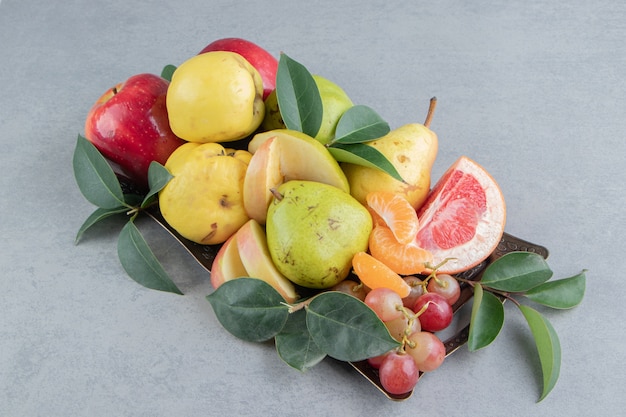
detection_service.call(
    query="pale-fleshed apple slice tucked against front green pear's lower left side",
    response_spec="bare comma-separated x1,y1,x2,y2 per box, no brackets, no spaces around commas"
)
235,219,298,303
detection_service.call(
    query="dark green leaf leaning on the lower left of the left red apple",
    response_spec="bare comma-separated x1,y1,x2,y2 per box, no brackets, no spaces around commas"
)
72,135,125,209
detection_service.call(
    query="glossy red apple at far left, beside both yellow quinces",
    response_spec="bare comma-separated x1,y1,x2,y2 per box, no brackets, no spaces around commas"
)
85,74,185,189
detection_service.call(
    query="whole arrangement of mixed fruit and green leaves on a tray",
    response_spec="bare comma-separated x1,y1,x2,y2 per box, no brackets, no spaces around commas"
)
73,38,585,399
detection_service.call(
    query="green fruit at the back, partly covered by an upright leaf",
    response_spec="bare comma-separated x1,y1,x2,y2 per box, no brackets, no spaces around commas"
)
261,75,354,145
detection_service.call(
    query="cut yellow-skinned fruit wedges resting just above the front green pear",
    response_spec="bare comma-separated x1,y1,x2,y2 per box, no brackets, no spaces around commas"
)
243,129,350,224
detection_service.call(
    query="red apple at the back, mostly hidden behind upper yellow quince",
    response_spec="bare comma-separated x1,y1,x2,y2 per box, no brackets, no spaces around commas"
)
198,38,278,100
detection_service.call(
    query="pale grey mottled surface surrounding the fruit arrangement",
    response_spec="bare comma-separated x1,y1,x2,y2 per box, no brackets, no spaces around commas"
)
0,0,626,417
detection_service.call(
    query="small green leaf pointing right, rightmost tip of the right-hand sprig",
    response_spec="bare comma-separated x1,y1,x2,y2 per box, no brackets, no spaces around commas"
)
524,271,586,309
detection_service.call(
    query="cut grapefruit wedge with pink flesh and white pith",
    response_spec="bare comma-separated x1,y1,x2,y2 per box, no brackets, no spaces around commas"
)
415,156,506,274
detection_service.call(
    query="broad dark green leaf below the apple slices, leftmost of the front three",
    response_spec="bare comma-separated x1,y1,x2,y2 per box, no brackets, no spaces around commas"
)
206,278,289,342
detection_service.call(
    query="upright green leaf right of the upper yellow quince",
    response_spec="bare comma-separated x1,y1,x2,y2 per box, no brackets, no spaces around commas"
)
276,53,324,137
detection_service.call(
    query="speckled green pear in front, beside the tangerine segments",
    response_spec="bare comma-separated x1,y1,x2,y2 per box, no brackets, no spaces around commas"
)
266,180,373,289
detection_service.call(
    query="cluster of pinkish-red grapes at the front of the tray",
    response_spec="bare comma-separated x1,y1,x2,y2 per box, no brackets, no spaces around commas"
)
335,273,461,395
